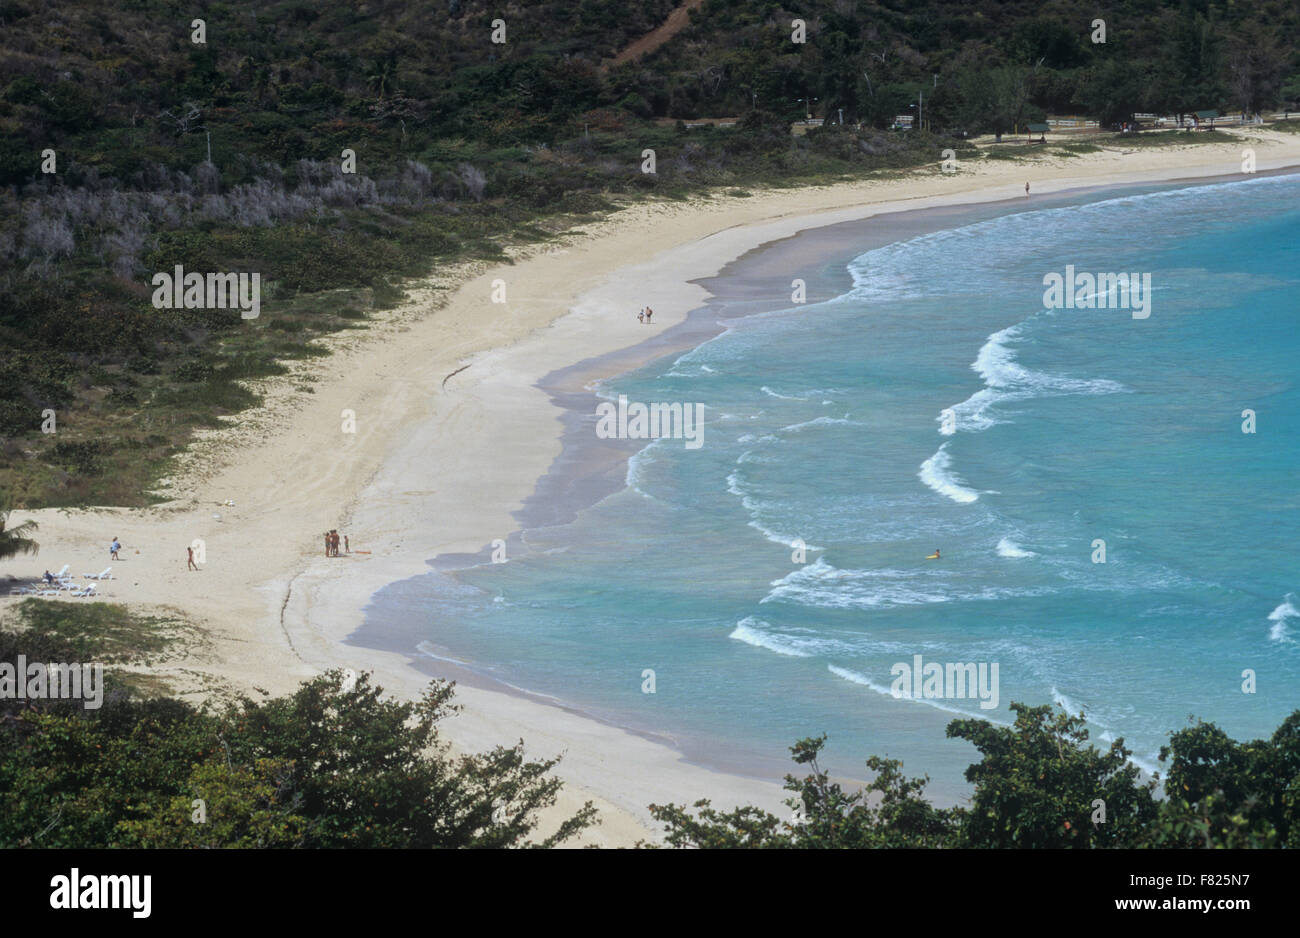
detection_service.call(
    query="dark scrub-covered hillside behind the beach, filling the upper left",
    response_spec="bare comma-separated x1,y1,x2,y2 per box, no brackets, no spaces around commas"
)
0,0,1300,507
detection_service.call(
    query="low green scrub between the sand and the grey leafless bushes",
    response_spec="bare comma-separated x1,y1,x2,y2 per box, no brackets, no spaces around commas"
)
0,196,613,508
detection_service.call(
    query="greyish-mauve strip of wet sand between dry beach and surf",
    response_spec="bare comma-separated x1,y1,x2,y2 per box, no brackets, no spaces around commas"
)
345,171,1178,805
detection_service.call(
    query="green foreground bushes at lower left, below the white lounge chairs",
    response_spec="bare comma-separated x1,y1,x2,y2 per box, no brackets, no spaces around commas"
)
0,600,593,847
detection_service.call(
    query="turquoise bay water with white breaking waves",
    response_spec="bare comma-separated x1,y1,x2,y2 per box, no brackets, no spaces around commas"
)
356,177,1300,796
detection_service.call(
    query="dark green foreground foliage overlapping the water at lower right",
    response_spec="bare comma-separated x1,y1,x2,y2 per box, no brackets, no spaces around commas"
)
650,703,1300,850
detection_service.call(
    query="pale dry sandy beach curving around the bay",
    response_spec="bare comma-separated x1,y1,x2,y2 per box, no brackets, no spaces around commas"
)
0,129,1300,846
